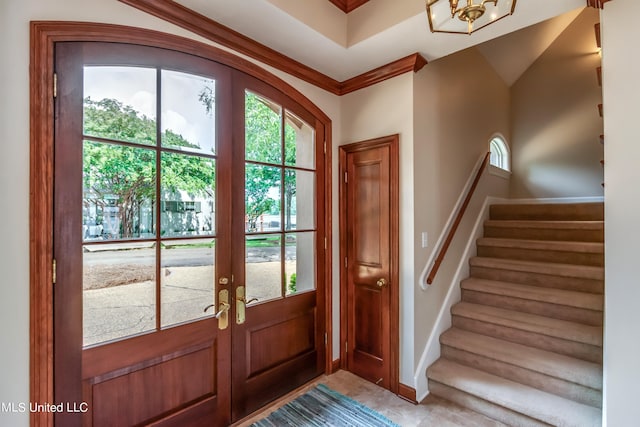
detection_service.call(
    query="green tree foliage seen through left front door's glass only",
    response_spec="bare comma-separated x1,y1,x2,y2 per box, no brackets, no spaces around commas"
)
83,98,215,238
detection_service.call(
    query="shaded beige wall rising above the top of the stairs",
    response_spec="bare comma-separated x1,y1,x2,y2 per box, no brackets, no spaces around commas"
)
510,8,603,197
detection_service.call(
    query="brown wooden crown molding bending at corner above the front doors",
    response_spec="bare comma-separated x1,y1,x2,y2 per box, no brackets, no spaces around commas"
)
118,0,427,96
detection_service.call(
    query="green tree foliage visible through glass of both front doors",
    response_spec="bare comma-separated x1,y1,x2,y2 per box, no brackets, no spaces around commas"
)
84,88,304,238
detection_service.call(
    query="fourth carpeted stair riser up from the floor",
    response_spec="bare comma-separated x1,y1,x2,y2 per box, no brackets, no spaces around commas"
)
462,289,602,326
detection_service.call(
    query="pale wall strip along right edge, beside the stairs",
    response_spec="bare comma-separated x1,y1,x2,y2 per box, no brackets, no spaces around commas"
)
602,0,640,427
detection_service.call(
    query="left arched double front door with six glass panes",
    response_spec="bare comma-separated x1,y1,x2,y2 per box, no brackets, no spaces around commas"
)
53,43,231,427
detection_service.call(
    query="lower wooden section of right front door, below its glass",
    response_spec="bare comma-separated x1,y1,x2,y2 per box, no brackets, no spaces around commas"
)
232,292,324,420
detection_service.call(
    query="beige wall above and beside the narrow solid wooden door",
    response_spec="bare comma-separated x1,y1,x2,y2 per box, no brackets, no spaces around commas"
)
340,73,415,386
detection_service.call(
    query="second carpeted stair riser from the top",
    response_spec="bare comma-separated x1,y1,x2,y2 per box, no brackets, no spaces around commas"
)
484,225,604,243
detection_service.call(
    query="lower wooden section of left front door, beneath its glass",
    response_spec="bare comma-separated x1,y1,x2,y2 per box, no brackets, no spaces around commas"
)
83,319,229,426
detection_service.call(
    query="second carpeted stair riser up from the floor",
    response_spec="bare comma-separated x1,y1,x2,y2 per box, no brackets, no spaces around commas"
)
441,345,602,408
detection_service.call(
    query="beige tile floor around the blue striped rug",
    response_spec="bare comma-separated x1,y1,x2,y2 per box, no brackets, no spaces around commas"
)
234,371,504,427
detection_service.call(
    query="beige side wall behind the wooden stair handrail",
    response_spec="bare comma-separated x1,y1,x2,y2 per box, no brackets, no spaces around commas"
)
412,49,510,375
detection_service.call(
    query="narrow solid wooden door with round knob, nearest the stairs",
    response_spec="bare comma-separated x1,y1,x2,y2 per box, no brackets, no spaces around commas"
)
340,136,399,392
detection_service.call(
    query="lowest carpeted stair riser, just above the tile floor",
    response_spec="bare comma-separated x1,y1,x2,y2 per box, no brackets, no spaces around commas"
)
429,379,549,427
